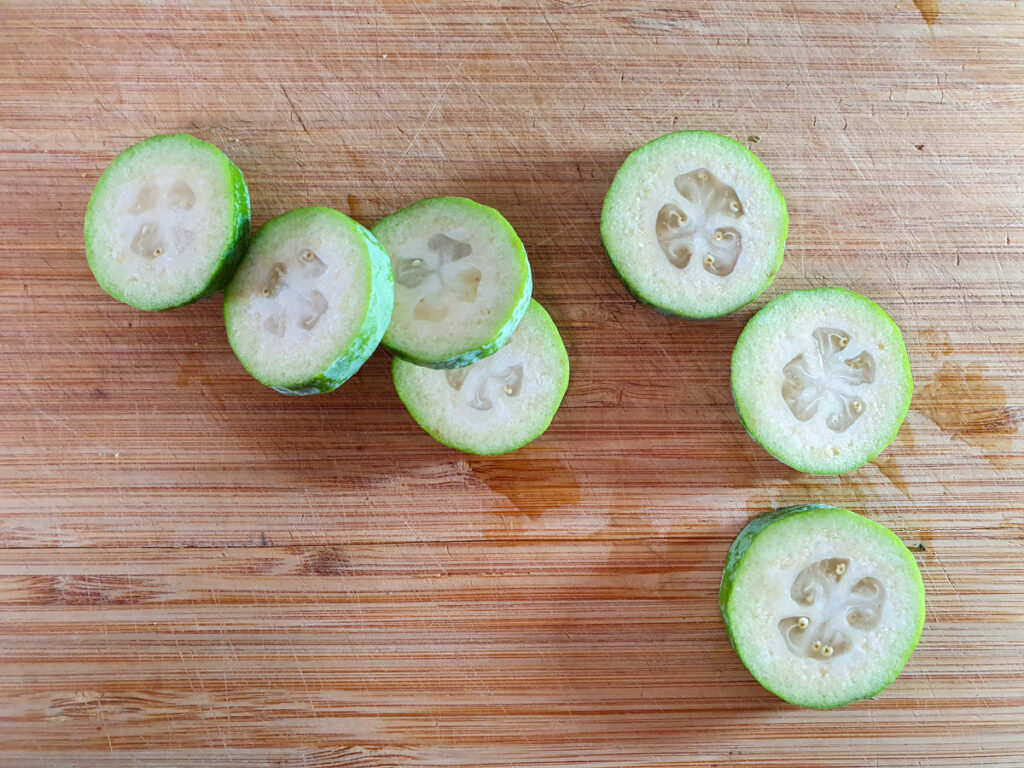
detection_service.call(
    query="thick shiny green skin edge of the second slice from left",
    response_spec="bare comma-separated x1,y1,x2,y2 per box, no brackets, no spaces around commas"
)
224,207,394,395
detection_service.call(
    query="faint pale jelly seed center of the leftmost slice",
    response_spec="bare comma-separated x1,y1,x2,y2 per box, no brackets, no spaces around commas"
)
125,179,196,259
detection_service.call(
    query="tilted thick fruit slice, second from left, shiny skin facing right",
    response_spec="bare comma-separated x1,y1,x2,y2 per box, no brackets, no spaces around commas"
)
224,208,394,394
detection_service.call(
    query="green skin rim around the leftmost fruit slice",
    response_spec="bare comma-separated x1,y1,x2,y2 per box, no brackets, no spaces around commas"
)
85,133,250,311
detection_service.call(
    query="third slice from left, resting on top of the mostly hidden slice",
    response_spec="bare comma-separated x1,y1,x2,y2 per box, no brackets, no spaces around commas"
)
373,198,532,368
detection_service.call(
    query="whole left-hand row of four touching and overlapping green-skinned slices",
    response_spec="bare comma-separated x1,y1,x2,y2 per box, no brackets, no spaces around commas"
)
85,133,568,454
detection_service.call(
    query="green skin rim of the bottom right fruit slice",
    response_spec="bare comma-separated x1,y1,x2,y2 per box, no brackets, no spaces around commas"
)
718,504,925,710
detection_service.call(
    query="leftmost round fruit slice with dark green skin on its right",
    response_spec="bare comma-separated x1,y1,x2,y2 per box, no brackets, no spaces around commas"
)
85,133,249,310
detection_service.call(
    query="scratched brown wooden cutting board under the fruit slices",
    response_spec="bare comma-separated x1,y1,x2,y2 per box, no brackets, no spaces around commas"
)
0,0,1024,768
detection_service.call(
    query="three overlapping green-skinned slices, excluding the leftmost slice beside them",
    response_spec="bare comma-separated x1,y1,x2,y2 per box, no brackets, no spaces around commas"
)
224,198,568,454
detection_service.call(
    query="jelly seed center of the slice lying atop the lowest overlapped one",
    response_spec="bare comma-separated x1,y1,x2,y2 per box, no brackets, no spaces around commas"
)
392,232,483,323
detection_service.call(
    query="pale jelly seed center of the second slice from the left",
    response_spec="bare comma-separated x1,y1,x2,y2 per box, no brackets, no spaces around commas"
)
258,248,330,336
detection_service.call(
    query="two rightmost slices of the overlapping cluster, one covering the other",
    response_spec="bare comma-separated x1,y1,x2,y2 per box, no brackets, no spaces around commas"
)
373,198,569,455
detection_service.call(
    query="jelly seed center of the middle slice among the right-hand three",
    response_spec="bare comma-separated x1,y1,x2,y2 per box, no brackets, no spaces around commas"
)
782,328,874,432
